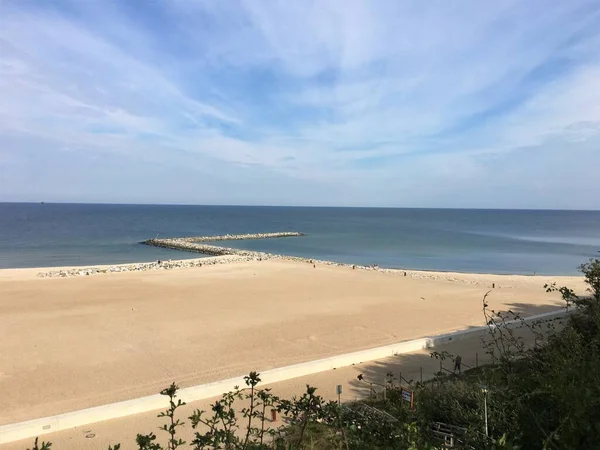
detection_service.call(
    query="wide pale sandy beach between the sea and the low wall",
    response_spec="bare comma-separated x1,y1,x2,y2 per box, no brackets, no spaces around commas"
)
0,260,584,424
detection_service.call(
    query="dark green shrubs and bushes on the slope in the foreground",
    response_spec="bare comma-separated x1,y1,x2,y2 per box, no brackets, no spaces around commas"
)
31,259,600,450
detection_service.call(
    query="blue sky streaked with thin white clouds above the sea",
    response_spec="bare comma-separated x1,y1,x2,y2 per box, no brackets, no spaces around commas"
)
0,0,600,209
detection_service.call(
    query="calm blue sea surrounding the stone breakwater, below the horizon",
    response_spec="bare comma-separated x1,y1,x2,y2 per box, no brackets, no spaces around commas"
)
0,203,600,274
